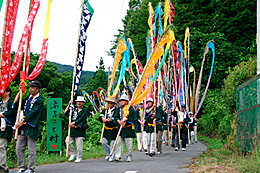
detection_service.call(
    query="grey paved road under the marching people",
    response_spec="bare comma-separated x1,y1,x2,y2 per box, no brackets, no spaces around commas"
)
10,142,207,173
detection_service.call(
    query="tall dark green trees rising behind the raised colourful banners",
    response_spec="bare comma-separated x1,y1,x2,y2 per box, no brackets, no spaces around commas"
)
109,0,256,89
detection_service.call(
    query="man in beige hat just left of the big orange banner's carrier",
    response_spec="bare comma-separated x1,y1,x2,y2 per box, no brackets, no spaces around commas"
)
99,97,118,162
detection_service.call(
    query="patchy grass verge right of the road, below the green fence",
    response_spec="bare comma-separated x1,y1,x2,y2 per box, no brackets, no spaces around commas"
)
190,136,260,172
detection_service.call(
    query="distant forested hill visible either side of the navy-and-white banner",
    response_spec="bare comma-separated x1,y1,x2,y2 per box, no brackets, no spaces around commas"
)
52,62,95,85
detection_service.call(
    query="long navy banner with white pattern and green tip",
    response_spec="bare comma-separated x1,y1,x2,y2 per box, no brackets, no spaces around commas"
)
73,0,94,99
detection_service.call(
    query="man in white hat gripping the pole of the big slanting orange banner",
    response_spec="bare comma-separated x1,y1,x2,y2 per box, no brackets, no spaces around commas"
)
114,95,137,162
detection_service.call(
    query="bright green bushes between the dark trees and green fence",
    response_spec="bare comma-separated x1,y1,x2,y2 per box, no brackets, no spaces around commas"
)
198,58,257,139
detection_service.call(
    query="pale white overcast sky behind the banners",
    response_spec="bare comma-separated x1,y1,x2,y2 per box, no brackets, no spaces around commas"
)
0,0,129,71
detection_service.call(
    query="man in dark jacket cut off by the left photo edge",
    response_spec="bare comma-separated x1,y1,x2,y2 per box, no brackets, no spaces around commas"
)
0,88,16,173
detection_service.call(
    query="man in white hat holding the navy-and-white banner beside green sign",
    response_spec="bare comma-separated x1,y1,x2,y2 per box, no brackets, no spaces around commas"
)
64,96,88,163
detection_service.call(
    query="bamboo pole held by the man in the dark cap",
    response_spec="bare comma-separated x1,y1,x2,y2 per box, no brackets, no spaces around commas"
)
14,1,32,140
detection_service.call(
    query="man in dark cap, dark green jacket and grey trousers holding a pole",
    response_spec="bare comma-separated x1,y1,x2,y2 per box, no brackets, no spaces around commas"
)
14,80,44,172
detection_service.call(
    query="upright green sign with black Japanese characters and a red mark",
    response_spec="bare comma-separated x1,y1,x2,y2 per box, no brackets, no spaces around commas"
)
47,98,62,151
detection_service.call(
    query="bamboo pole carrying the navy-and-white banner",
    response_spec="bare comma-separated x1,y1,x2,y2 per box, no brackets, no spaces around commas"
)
66,1,84,157
